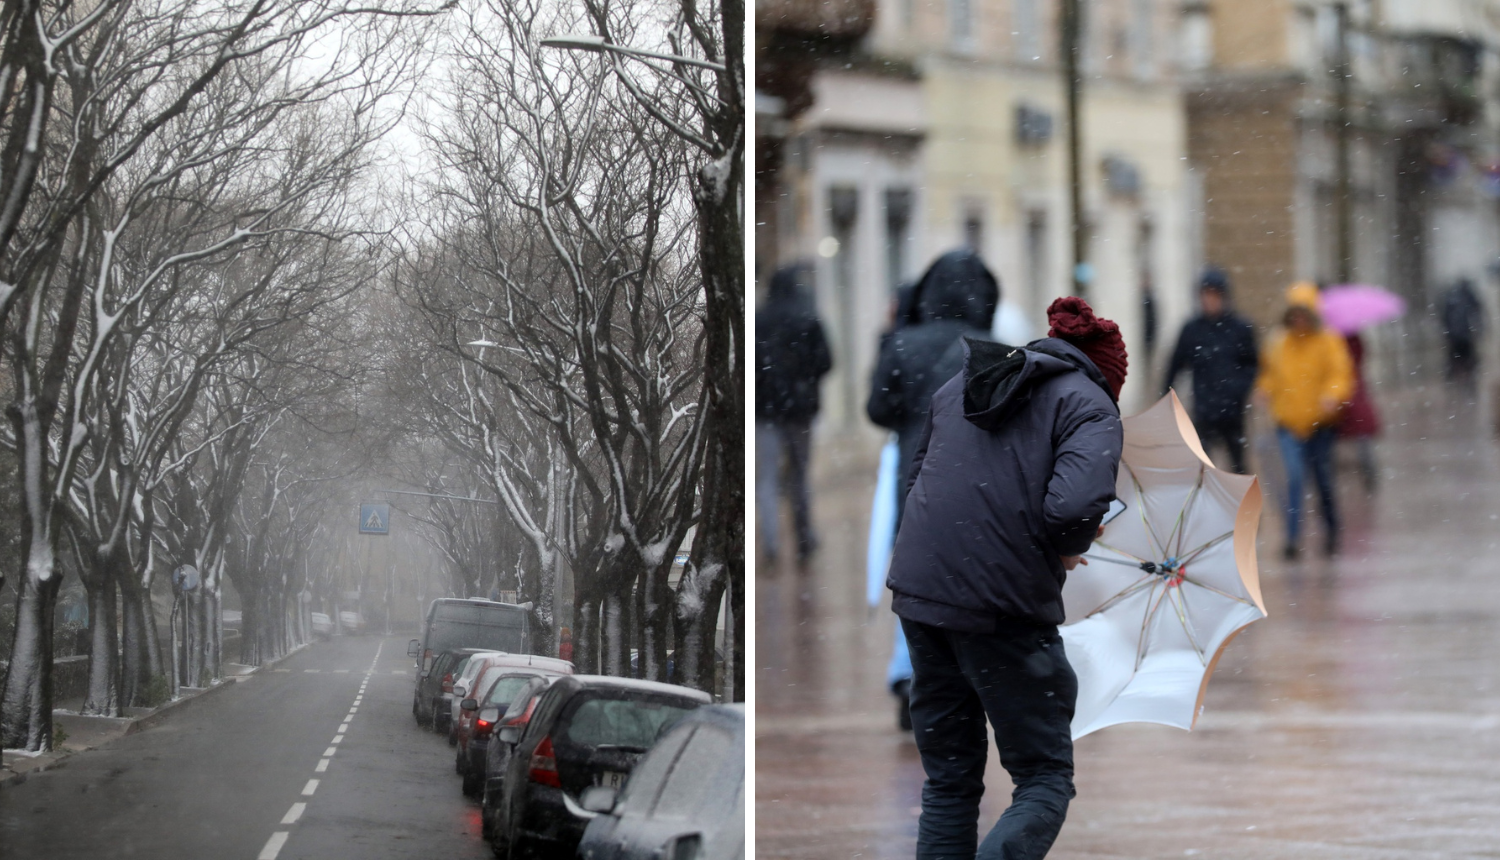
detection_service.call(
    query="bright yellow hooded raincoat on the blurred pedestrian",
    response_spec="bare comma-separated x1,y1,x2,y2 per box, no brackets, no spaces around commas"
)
1256,329,1355,438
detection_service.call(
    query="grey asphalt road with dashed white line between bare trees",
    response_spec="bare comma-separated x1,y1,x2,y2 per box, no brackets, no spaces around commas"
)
0,636,491,860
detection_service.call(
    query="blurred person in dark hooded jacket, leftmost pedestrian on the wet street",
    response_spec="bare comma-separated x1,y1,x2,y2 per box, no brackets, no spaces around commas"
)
755,264,833,561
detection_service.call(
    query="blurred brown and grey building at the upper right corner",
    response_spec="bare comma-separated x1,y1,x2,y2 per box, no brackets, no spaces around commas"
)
1179,0,1500,331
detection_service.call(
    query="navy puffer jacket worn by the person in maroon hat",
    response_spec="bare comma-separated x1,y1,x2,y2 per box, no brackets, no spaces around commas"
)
887,338,1124,633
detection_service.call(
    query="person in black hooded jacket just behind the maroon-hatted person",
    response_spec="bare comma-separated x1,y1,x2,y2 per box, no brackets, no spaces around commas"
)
866,249,1001,729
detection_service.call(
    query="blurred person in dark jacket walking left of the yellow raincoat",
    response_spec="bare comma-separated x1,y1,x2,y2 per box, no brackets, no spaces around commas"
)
1161,266,1259,474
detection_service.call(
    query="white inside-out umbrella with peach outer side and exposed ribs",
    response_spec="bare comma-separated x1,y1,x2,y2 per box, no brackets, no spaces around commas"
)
1061,392,1266,738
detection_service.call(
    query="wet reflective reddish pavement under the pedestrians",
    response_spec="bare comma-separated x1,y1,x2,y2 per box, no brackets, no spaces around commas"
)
756,386,1500,860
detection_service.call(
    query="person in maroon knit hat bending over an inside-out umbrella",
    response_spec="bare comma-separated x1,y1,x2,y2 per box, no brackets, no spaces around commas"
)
887,299,1128,860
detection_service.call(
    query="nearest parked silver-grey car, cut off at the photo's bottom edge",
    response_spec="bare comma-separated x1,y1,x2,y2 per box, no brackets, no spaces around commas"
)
578,705,746,860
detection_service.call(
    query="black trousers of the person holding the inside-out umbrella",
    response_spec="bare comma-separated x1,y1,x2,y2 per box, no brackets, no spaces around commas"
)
902,618,1079,860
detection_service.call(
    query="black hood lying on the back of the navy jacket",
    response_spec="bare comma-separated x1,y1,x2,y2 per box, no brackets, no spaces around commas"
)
963,338,1115,431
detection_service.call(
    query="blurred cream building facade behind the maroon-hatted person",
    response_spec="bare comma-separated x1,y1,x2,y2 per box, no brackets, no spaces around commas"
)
756,0,1200,428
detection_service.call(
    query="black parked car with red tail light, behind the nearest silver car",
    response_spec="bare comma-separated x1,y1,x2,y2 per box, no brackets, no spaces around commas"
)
491,675,710,860
